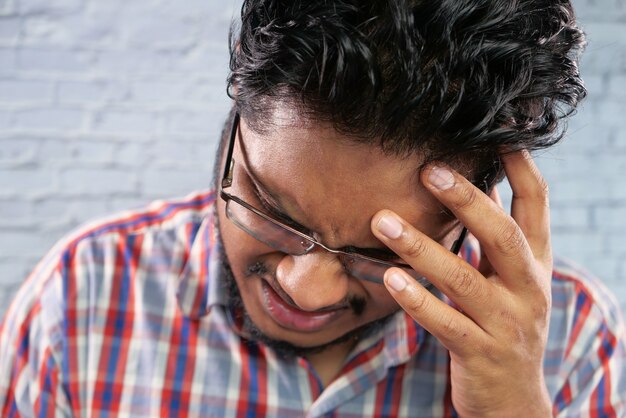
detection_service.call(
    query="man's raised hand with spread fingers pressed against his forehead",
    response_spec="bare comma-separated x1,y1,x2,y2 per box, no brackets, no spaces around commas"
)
372,151,552,418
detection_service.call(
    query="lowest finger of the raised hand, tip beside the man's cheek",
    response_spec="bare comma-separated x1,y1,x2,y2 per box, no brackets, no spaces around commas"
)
385,268,485,356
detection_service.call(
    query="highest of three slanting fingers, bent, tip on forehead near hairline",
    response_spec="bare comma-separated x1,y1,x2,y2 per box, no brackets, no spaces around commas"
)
422,166,536,289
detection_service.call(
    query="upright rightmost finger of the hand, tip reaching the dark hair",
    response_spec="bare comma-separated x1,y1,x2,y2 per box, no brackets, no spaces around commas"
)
502,151,552,264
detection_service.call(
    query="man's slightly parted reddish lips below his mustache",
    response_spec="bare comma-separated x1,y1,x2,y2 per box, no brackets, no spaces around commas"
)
261,280,346,332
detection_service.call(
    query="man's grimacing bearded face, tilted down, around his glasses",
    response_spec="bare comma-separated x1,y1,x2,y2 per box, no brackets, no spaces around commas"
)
218,107,456,348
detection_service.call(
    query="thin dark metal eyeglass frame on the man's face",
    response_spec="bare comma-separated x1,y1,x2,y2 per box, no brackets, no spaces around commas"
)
220,112,468,284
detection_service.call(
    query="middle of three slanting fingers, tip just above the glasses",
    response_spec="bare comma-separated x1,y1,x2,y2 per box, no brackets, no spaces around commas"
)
372,210,497,326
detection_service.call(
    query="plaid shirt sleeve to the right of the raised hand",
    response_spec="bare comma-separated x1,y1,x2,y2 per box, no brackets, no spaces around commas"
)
545,270,626,418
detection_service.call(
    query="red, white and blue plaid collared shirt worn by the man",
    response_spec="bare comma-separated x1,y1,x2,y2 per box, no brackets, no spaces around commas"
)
0,192,626,417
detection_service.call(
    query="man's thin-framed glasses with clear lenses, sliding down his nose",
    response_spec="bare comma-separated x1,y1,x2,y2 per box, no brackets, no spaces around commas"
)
220,113,467,286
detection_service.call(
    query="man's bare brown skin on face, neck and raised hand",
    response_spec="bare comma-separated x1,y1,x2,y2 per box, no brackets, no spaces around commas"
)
218,107,551,417
